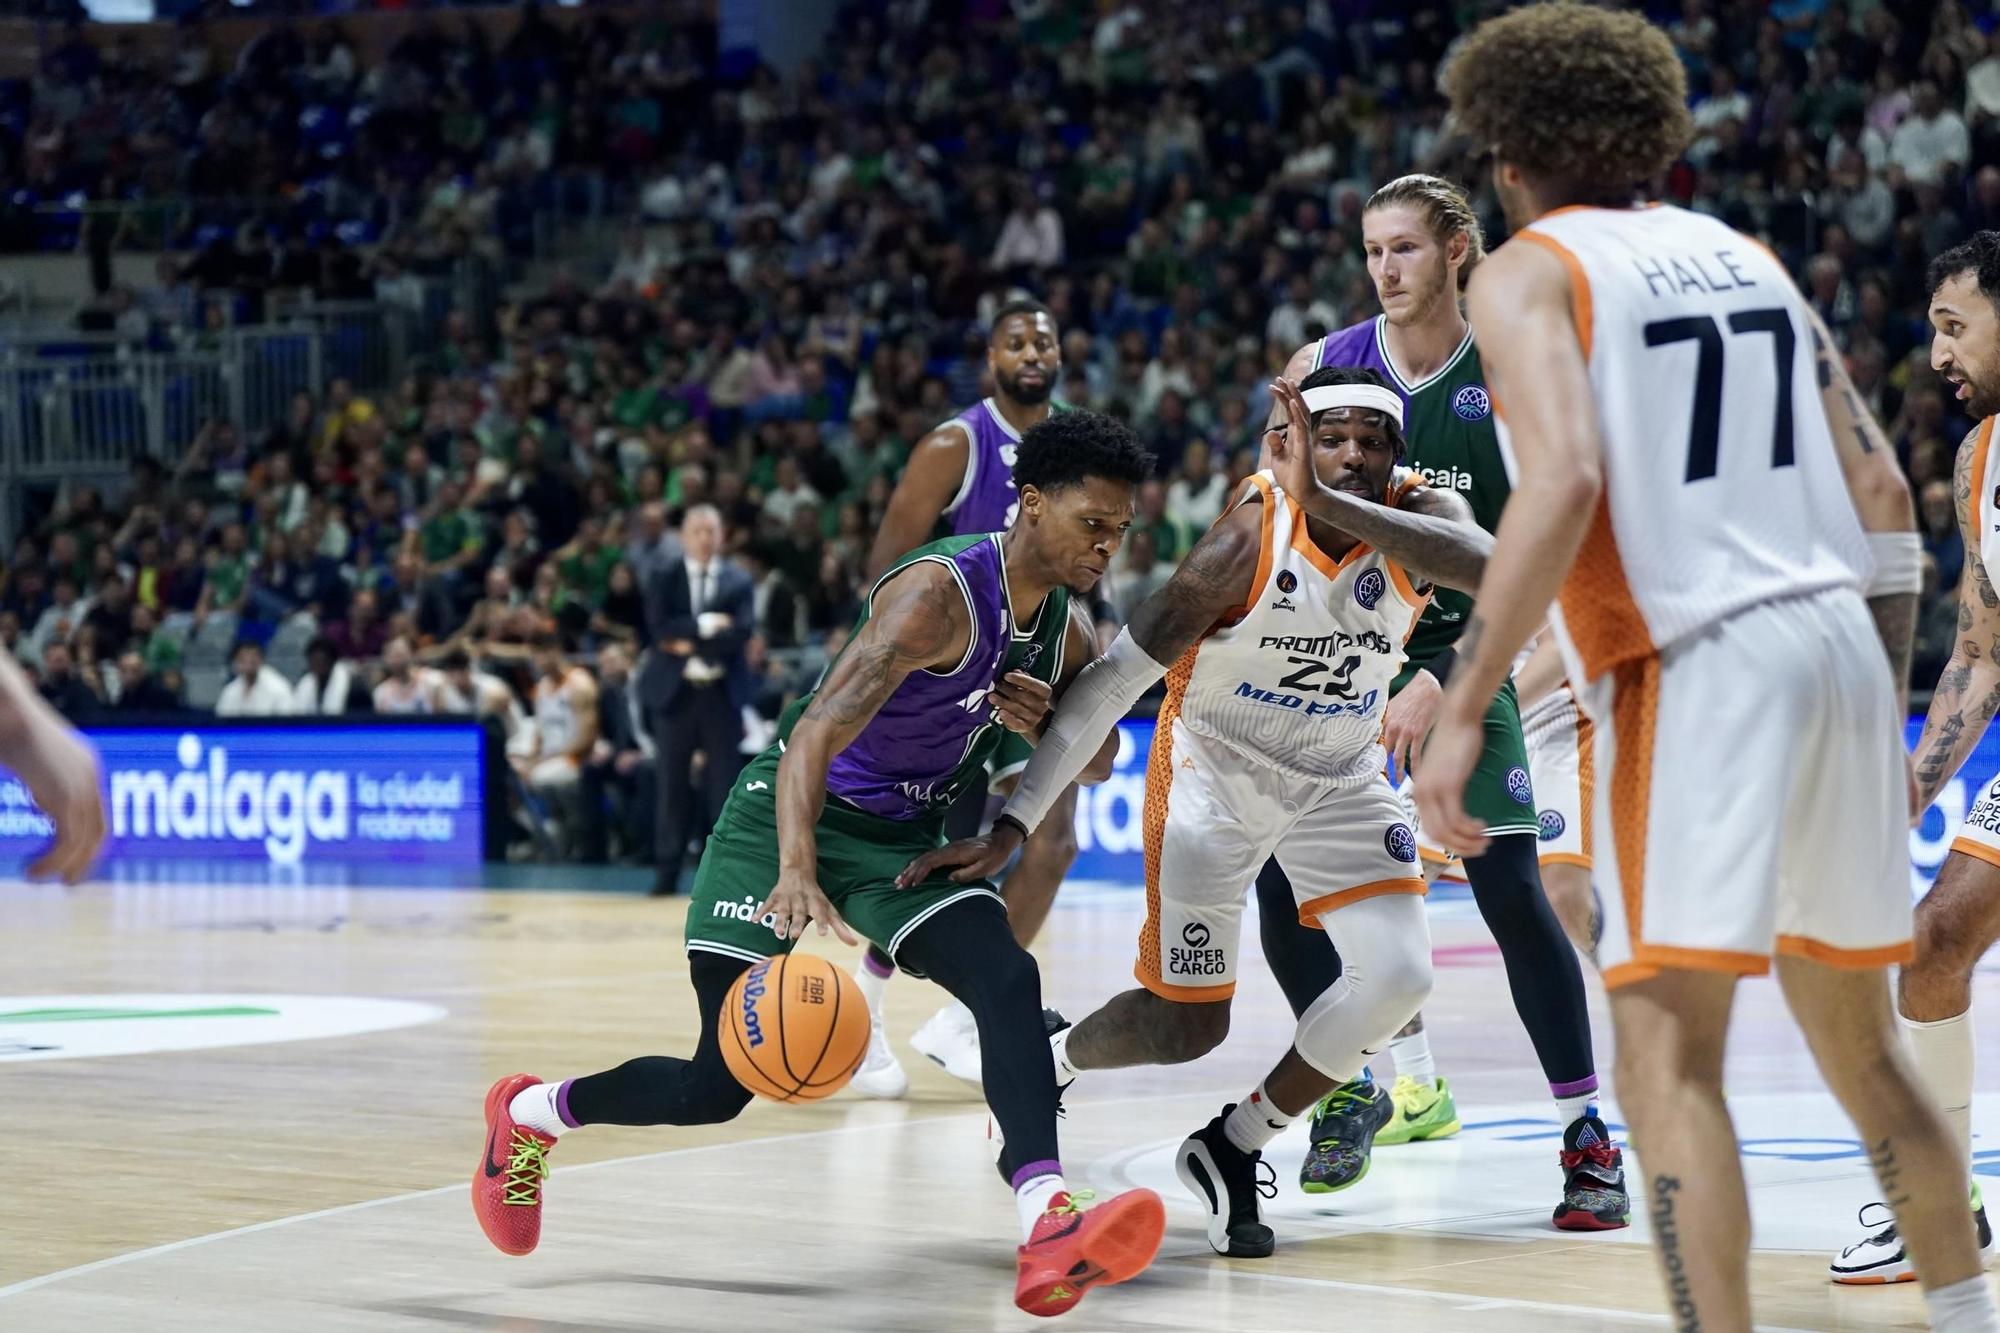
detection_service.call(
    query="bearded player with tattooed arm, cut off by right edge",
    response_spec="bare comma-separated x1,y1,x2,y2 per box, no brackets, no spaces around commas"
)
1832,232,2000,1285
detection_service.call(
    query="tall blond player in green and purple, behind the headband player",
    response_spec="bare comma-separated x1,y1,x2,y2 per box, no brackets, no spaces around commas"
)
1258,176,1632,1231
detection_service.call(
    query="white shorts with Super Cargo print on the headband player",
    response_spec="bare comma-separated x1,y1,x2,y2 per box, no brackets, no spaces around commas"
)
1132,717,1424,1003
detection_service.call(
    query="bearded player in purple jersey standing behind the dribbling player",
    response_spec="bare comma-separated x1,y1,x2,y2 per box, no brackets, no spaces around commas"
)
854,300,1076,1097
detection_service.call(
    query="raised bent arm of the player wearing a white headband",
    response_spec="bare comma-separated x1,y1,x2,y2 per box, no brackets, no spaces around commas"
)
1266,380,1494,592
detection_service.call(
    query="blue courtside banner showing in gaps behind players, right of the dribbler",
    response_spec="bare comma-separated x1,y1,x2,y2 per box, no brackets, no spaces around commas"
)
1070,717,2000,895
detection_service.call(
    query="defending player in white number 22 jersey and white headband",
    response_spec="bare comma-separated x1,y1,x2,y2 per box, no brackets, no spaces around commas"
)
912,368,1490,1257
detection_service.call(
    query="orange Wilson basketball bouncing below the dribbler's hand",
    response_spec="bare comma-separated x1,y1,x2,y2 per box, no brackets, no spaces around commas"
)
722,953,868,1101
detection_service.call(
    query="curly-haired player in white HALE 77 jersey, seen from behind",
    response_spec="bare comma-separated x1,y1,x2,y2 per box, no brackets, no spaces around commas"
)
1416,4,2000,1333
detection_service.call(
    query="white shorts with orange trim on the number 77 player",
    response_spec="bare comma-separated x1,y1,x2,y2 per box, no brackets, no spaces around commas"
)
1582,588,1912,987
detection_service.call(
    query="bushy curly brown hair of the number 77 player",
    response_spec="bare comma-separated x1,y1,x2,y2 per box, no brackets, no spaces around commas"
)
1440,4,1694,200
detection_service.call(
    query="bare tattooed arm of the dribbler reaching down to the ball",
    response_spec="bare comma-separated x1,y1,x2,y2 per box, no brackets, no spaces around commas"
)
756,560,972,932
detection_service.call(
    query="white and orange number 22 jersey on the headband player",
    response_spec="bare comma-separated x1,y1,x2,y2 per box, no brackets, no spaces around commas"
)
1162,468,1430,783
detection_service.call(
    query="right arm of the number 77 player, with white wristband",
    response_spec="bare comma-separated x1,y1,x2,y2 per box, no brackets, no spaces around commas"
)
1800,300,1912,704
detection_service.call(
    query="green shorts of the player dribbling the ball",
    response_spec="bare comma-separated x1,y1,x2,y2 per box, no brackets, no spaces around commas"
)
686,747,1000,971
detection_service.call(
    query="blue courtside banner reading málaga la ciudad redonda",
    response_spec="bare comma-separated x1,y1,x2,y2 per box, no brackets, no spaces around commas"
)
0,723,486,875
